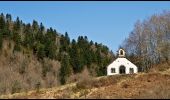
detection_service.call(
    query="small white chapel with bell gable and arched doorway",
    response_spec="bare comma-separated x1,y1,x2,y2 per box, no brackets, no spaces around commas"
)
107,49,138,75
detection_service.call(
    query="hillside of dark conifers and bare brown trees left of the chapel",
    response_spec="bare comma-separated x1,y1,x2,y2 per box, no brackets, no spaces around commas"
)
0,13,115,94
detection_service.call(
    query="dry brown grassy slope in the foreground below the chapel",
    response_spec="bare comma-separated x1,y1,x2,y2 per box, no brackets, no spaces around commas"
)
0,64,170,98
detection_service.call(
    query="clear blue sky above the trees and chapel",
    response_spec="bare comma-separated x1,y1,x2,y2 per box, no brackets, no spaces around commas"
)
0,1,170,52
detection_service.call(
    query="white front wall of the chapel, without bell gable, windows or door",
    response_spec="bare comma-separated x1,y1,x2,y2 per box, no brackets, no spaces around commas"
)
107,58,138,75
